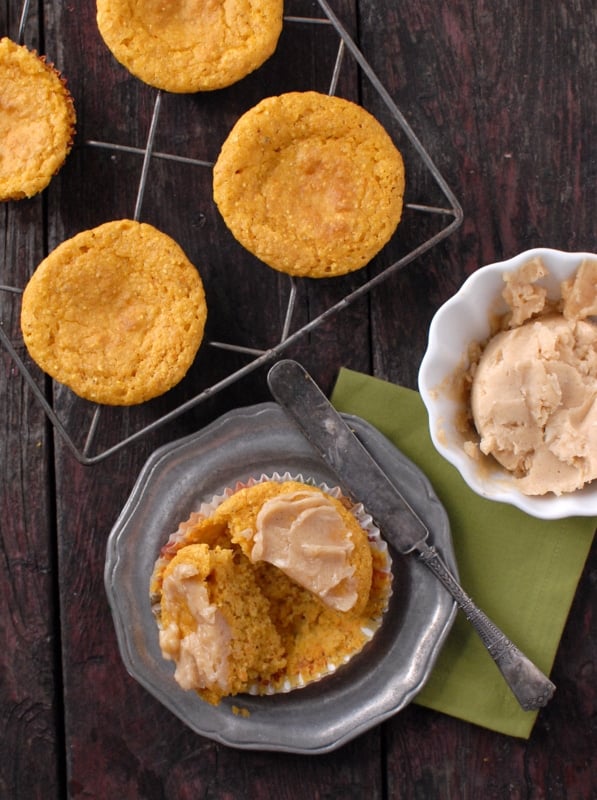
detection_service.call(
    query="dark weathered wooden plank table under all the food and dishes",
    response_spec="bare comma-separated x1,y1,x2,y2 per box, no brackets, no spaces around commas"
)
0,0,597,800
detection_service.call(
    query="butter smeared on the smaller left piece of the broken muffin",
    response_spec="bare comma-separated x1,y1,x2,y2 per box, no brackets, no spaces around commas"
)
159,564,232,692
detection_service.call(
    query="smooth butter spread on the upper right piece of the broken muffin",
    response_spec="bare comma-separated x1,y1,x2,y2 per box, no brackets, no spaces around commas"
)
249,491,357,611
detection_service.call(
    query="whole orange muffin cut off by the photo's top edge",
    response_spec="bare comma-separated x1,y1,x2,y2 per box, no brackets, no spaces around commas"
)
97,0,283,93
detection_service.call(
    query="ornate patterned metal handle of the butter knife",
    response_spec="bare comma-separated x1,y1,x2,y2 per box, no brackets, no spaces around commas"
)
417,543,555,711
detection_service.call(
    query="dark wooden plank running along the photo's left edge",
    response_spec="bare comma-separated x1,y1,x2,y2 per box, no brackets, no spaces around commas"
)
0,4,63,799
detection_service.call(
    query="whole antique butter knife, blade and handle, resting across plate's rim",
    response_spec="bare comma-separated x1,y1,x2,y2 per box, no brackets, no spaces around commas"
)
267,359,555,711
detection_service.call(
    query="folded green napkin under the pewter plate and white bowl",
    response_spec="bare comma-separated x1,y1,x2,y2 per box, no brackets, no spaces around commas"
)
331,369,596,738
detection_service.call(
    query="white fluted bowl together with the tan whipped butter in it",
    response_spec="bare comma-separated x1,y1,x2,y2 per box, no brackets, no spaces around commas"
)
419,248,597,519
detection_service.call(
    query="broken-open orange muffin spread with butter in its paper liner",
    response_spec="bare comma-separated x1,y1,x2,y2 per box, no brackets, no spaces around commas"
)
150,475,391,704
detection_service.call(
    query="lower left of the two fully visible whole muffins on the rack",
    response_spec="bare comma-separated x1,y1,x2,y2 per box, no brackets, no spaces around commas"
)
21,219,207,406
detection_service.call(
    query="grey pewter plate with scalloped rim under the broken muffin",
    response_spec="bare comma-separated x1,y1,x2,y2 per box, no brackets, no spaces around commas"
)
104,403,457,754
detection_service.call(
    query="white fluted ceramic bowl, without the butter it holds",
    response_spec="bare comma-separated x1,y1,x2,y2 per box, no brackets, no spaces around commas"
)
419,248,597,519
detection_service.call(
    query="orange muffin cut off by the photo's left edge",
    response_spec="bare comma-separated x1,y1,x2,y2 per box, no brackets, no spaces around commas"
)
0,38,76,201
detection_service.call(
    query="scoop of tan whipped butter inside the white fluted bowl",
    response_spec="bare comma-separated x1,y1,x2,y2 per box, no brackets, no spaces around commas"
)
470,259,597,495
